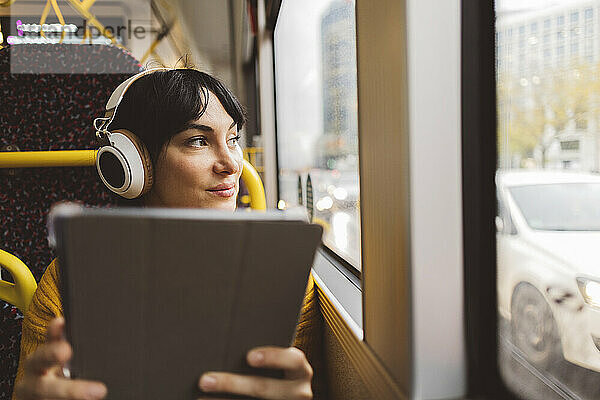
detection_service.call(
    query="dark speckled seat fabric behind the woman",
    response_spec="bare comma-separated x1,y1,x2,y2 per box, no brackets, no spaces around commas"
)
0,44,141,400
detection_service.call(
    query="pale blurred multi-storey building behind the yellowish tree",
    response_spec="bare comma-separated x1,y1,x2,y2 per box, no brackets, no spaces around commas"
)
496,0,600,171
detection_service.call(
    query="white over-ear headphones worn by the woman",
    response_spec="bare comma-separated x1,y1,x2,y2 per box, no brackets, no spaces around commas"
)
94,68,172,199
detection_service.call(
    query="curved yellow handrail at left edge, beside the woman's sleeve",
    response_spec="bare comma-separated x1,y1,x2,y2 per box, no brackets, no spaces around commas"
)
0,250,37,313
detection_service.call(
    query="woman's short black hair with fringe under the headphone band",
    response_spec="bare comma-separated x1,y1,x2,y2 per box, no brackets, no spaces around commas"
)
109,68,246,165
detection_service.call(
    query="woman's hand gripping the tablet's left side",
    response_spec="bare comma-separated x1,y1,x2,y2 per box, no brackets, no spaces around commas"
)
15,318,106,400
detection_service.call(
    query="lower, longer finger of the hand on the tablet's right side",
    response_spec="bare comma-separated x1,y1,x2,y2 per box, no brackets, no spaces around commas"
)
199,372,312,400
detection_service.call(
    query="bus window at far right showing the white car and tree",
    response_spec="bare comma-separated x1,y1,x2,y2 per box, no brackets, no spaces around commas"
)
496,0,600,399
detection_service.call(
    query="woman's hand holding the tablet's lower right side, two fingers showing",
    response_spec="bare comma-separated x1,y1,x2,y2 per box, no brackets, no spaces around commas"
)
199,347,313,400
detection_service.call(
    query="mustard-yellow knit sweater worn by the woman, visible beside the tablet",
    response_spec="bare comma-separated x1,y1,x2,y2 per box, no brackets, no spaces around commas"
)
13,259,321,400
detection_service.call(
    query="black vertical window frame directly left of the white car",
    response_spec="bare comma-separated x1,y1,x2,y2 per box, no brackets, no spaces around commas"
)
461,0,518,400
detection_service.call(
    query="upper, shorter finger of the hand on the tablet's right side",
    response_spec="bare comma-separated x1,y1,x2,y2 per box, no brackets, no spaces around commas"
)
247,346,313,379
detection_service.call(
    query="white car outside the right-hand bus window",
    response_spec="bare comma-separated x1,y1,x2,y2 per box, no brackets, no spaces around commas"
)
496,171,600,372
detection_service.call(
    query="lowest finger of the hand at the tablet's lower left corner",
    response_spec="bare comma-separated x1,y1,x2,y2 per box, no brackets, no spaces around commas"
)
15,376,107,400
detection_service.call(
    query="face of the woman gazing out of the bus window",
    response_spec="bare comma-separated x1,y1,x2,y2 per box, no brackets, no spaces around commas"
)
144,93,243,210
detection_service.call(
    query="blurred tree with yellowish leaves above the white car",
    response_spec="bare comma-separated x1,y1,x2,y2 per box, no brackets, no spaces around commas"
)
497,64,600,167
